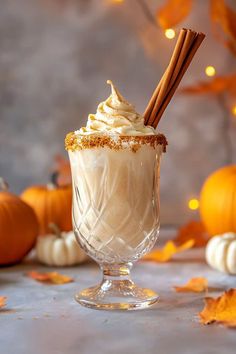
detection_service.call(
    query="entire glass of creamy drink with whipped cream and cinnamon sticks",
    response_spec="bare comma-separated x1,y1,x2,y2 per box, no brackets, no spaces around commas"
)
66,29,204,310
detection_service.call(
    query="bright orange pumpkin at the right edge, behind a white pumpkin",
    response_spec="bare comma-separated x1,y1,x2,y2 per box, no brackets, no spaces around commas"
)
200,165,236,235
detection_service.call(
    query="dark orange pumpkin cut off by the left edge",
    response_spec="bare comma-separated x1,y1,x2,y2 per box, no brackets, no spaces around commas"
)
0,178,38,265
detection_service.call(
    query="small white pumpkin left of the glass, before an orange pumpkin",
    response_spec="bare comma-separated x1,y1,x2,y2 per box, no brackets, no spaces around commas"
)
36,224,88,267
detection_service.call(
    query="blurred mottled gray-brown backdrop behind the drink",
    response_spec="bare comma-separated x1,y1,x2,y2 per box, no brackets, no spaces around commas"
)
0,0,236,224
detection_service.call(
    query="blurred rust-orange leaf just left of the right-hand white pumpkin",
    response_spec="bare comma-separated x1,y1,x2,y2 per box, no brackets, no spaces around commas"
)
174,220,210,247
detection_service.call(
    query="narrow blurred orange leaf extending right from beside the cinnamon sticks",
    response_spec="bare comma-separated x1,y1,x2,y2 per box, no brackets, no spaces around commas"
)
179,73,236,96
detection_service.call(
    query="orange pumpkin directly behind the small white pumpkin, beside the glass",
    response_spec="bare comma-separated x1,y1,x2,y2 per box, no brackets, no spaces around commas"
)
21,174,72,235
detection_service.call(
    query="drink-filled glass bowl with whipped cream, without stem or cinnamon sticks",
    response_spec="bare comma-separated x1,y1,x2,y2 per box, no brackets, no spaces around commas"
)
66,81,167,263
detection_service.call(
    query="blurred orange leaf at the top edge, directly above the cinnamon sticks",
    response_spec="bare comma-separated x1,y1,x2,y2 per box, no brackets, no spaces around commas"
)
156,0,193,29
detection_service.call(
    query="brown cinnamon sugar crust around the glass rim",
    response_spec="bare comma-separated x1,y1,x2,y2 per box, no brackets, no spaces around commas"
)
65,132,168,152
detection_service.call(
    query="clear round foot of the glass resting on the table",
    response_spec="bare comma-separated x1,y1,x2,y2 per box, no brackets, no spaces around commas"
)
75,279,159,310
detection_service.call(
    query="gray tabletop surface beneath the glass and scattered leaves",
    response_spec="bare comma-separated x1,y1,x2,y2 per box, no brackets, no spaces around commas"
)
0,231,236,354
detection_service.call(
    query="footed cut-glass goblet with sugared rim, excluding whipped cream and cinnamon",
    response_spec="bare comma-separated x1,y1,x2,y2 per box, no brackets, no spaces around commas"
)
67,135,165,310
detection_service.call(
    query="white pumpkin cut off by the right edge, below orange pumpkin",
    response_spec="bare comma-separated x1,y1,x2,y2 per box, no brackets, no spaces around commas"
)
206,232,236,274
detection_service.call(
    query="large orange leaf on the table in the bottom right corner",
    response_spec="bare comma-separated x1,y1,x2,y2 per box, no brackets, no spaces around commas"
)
199,289,236,327
